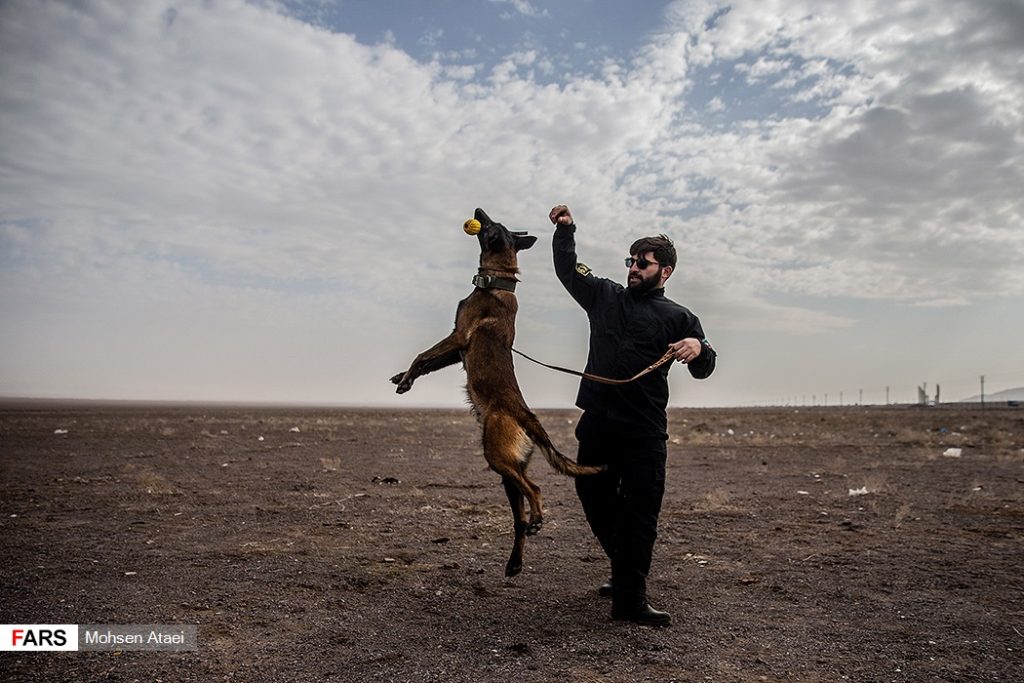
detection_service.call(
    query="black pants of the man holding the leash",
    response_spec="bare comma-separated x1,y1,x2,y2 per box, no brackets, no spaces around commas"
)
575,414,666,607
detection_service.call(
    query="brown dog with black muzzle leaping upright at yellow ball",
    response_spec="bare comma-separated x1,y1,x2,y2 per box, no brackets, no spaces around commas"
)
391,209,604,577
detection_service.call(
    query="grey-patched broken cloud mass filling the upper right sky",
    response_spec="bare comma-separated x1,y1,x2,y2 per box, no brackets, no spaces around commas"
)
646,2,1024,302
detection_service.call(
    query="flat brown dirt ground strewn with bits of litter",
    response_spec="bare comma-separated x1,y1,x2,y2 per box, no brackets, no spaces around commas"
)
0,403,1024,683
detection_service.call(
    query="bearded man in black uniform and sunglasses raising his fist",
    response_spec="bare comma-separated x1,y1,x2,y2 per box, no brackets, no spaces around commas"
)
549,205,716,626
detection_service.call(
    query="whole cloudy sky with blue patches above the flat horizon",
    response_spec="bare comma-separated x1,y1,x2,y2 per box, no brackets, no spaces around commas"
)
0,0,1024,408
